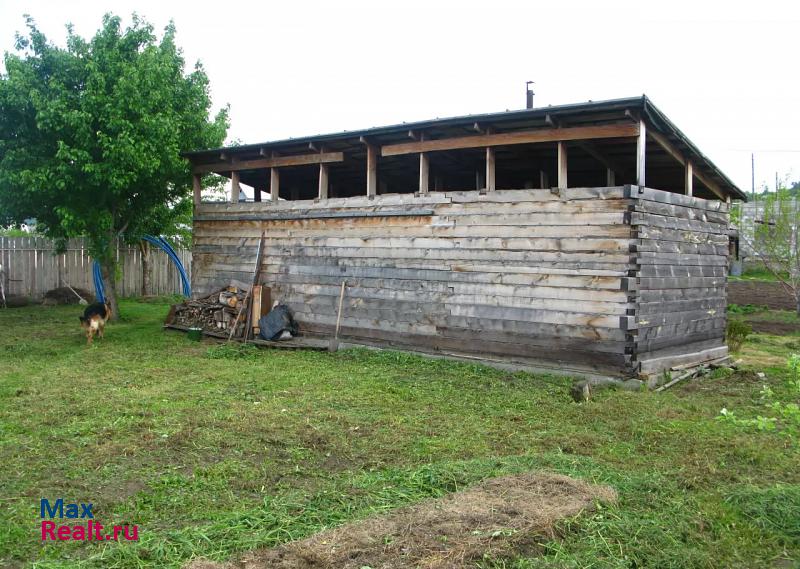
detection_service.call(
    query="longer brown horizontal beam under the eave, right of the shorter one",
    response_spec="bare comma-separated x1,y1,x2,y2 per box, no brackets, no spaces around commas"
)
381,123,639,156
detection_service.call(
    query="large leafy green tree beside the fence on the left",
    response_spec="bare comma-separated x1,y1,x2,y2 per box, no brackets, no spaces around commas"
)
0,14,228,315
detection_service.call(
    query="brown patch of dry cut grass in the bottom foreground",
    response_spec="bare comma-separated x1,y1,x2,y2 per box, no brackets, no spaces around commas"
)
185,473,616,569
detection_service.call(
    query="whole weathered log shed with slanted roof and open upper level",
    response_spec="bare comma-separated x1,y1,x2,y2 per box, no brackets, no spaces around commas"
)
186,97,746,375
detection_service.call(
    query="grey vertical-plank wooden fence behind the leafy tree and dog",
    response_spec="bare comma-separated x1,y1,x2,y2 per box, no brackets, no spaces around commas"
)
0,237,192,300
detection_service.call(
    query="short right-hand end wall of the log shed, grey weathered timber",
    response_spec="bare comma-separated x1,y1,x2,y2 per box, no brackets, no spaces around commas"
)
631,187,729,374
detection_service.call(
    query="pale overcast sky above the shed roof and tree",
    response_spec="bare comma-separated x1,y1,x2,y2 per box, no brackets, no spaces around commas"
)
0,0,800,191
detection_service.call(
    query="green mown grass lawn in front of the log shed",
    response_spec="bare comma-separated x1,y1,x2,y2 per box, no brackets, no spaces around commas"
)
0,301,800,569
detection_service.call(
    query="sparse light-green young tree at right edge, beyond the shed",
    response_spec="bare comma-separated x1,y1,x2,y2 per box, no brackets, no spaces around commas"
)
732,189,800,315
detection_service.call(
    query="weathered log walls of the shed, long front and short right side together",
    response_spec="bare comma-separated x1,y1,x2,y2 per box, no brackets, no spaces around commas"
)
192,186,727,374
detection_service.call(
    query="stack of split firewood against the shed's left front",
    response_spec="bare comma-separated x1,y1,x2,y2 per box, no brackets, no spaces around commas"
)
172,284,247,336
